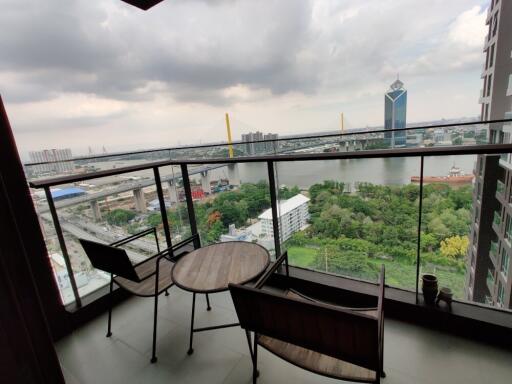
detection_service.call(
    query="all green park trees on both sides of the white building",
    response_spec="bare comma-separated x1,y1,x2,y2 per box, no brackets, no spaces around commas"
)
133,181,472,297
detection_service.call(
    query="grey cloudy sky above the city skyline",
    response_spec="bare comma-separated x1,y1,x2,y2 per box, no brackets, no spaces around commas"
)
0,0,488,157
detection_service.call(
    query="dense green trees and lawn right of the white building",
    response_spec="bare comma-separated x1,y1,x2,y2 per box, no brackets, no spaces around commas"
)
286,181,472,297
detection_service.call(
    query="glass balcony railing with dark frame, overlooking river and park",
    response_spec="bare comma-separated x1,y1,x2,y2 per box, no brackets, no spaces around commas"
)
23,121,512,316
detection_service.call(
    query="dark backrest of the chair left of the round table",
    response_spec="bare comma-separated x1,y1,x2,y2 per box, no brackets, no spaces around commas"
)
80,239,141,282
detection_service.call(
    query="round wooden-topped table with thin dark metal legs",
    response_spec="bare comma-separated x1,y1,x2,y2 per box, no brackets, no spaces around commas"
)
171,241,270,355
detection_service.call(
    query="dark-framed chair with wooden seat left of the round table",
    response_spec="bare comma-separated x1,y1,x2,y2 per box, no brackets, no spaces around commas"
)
80,234,198,363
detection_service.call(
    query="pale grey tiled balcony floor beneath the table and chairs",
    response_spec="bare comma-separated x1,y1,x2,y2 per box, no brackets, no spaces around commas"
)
57,287,512,384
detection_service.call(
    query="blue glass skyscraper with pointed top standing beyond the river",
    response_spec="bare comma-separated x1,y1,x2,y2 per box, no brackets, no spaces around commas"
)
384,78,407,147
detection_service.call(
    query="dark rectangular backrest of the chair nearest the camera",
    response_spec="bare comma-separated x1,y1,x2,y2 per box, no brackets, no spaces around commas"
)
229,284,380,371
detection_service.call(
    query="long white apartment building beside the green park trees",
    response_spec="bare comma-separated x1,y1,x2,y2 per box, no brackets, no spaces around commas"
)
258,193,309,241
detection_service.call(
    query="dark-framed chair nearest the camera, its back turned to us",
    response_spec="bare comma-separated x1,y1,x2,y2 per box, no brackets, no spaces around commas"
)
229,254,385,383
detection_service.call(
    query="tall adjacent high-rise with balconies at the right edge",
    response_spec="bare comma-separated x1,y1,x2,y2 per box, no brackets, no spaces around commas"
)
466,0,512,308
